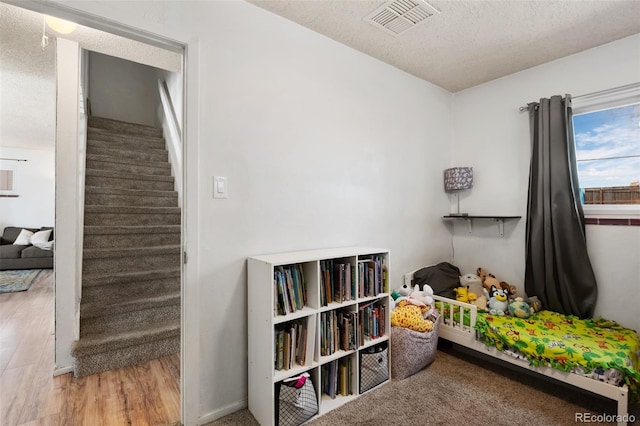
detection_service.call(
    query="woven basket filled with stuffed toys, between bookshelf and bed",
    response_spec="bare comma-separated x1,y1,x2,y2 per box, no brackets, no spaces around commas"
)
391,314,439,380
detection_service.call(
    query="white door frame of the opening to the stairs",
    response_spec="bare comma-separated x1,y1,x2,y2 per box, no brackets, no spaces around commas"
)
3,0,200,425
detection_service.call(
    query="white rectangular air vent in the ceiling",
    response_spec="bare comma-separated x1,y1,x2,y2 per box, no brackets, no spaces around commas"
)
364,0,440,36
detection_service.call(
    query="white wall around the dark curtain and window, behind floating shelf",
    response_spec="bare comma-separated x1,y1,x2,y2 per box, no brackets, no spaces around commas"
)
452,35,640,330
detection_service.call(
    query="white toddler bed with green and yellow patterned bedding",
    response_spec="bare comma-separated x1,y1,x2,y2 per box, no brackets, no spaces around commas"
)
405,273,640,425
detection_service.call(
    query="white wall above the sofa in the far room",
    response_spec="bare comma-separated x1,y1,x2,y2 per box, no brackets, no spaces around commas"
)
0,147,55,232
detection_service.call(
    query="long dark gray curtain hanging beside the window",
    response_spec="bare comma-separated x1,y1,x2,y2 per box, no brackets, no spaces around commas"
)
524,95,598,318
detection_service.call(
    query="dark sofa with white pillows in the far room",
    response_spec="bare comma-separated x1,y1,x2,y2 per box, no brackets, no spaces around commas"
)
0,226,53,271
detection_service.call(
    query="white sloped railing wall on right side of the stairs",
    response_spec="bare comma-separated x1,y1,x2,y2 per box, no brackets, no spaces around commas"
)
158,80,182,207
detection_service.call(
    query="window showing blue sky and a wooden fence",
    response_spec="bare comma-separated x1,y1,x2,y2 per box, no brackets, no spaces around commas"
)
573,84,640,217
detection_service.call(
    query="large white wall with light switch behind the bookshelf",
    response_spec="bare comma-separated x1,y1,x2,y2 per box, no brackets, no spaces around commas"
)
53,1,452,423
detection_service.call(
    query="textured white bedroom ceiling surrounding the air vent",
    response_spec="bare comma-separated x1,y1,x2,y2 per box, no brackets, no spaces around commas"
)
248,0,640,92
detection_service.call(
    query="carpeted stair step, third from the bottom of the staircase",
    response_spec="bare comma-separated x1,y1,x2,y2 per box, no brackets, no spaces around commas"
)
82,267,180,303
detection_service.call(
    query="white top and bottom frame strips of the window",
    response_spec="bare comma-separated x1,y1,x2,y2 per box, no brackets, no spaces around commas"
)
571,82,640,219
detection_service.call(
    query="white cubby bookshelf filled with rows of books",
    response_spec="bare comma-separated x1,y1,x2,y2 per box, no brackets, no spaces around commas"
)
247,247,391,426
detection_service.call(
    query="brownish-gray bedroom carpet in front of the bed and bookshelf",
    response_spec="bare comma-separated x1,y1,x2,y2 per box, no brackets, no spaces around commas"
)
209,344,640,426
